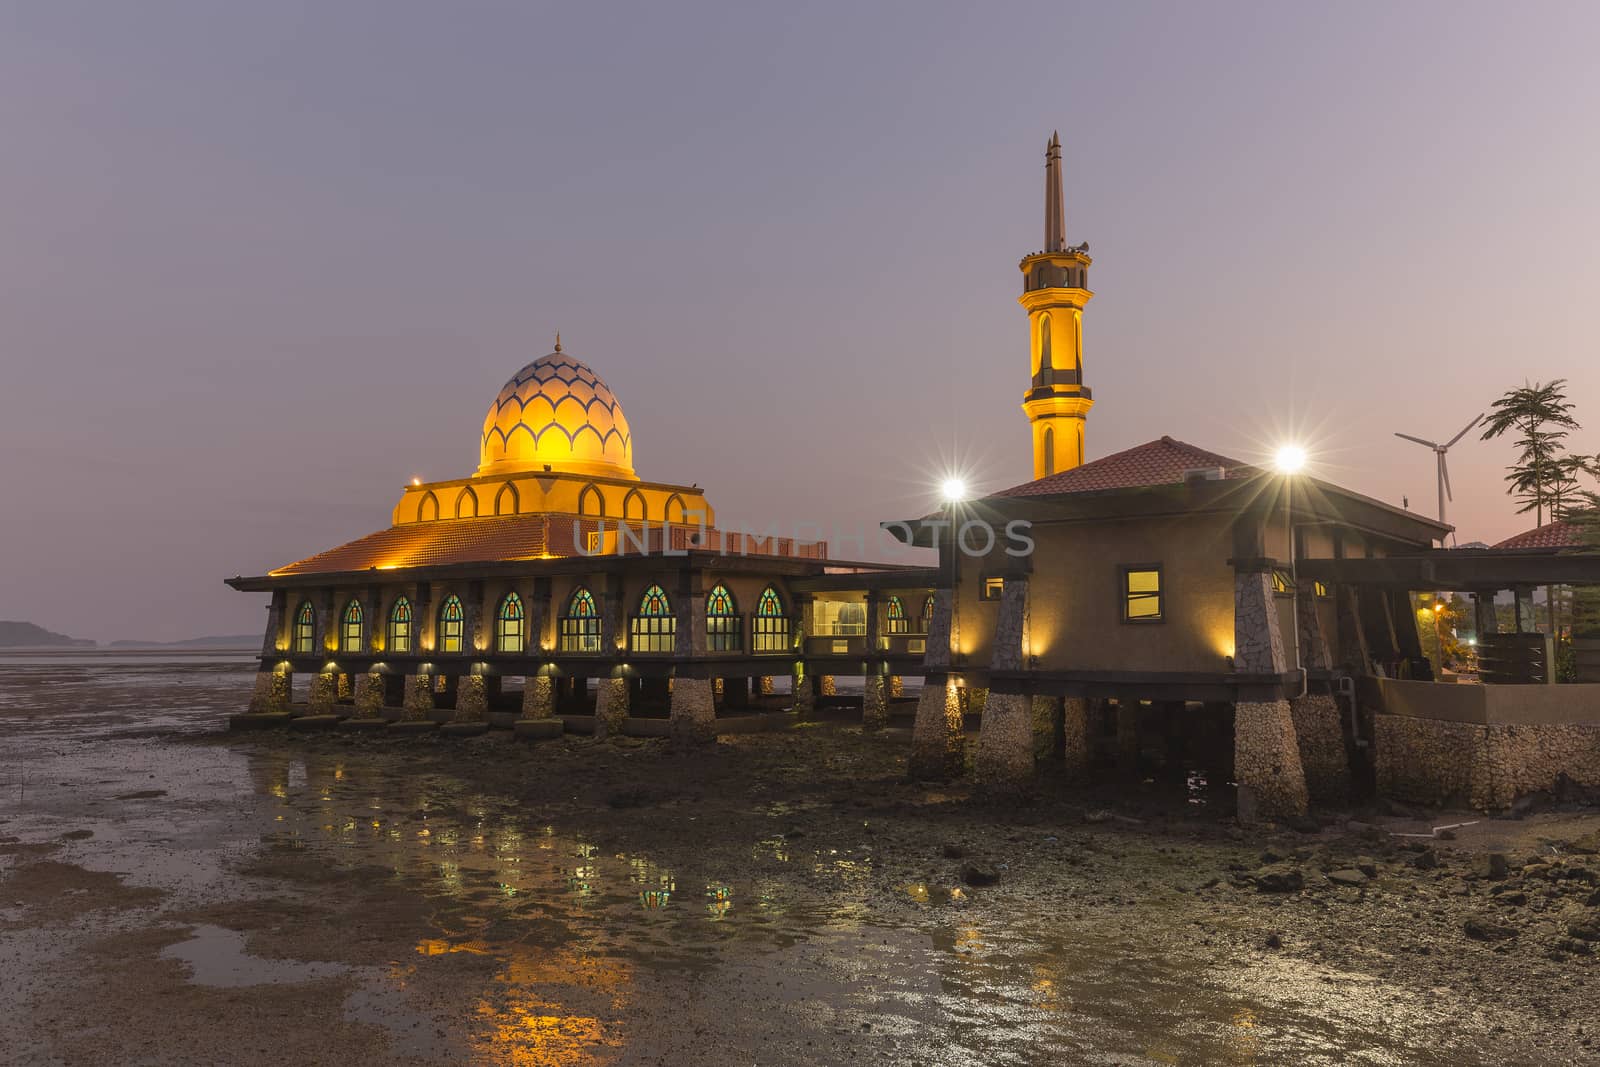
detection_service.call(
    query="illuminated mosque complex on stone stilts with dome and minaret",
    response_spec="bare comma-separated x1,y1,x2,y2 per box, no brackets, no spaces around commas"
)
229,136,1600,816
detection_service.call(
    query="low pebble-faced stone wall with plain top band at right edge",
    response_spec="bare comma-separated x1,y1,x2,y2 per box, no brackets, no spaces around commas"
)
1373,715,1600,811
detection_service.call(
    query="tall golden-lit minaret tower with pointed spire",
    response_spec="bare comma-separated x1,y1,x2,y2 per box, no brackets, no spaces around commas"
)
1018,134,1094,478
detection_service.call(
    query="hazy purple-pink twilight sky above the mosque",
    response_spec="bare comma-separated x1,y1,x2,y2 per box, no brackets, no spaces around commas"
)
0,0,1600,640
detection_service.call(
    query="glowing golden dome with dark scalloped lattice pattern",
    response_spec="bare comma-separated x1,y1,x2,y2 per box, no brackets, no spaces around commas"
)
478,338,638,478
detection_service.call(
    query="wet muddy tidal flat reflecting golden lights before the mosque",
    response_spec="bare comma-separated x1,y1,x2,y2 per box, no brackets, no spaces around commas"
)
0,659,1600,1067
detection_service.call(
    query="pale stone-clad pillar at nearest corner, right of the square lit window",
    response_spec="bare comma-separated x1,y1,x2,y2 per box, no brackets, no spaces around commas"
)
1234,568,1306,822
